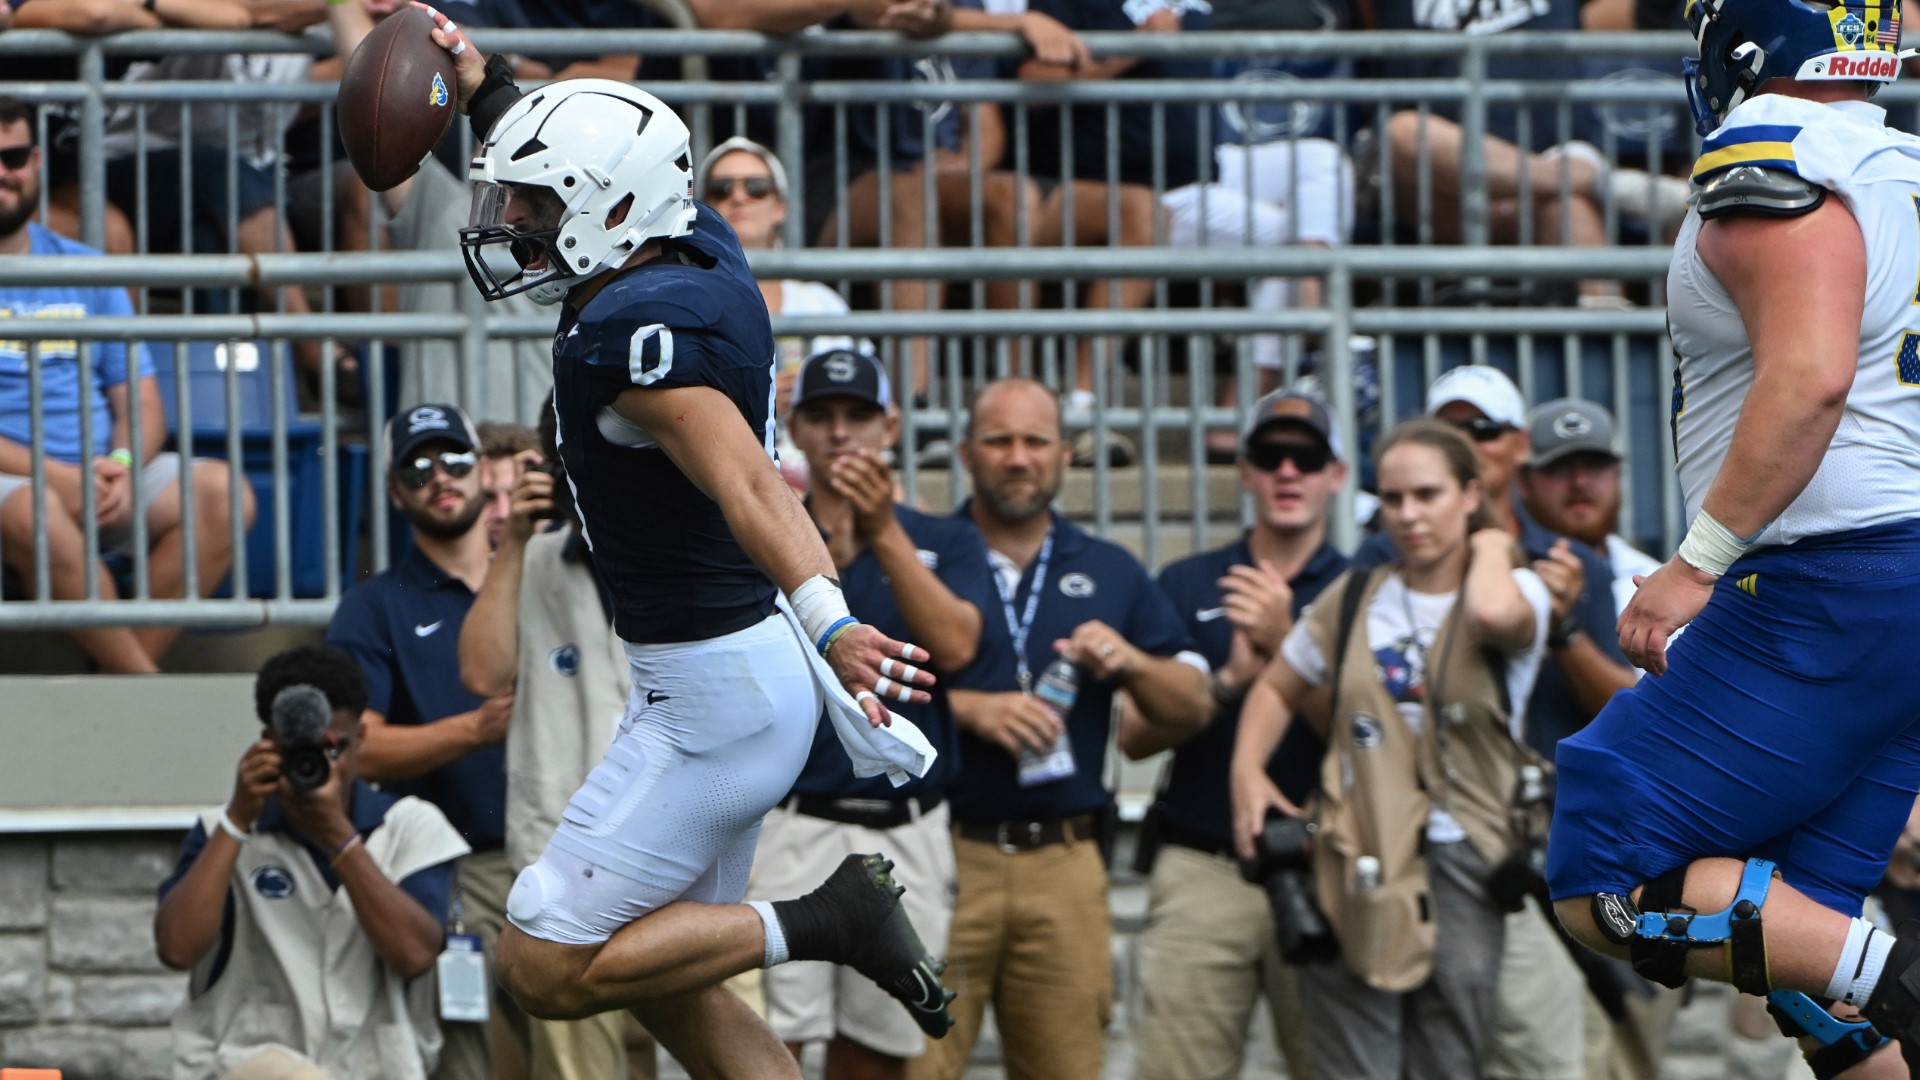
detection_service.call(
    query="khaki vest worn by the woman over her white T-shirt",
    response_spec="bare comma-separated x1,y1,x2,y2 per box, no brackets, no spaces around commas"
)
1308,565,1538,992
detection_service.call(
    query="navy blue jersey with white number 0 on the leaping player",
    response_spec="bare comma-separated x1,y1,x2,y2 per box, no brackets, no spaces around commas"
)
553,204,774,644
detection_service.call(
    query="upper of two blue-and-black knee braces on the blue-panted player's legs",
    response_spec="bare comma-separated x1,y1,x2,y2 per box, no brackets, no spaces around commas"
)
1594,859,1774,997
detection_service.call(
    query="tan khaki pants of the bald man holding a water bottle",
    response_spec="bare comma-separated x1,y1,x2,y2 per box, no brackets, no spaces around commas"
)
906,826,1114,1080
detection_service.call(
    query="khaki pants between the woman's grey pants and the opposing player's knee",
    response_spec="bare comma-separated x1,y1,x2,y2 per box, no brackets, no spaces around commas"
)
1486,899,1592,1080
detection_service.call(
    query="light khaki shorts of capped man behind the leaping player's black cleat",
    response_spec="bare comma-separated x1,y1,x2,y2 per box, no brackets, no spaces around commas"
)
747,803,954,1057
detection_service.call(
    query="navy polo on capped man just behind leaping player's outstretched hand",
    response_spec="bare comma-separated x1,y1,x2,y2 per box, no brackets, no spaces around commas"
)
793,505,1000,801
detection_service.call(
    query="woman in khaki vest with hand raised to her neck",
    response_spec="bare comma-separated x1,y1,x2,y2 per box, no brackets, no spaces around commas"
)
1233,419,1549,1080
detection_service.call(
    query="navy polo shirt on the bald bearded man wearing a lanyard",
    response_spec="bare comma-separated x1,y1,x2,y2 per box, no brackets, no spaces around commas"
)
948,502,1194,822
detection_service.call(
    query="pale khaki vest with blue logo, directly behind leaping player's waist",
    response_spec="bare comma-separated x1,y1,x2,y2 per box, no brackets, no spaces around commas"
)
507,530,632,871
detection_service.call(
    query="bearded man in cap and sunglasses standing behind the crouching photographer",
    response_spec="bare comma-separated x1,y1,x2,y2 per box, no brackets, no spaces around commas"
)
326,405,516,1080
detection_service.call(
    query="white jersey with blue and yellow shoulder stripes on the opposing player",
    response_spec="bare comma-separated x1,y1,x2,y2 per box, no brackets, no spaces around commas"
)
1667,94,1920,544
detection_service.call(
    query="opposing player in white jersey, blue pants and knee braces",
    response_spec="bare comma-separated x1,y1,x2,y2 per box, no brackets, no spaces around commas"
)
1548,0,1920,1080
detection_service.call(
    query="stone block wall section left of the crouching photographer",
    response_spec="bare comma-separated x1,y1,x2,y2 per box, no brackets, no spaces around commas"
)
0,832,186,1080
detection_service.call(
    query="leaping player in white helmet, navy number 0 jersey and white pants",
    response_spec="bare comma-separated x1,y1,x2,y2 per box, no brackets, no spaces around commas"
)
426,8,952,1078
